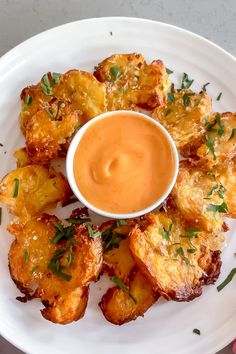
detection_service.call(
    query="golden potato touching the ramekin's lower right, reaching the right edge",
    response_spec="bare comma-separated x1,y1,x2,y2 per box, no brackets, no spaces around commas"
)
171,161,236,231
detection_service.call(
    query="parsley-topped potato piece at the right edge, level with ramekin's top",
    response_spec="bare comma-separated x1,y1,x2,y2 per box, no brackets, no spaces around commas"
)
197,112,236,168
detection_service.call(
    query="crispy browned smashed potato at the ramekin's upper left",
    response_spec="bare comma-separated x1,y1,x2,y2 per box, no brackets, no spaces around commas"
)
20,70,106,164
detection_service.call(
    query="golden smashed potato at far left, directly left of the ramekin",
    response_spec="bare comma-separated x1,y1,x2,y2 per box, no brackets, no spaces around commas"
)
0,165,71,223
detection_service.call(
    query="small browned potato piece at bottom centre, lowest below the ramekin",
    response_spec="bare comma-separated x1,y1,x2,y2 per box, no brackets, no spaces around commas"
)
99,268,159,325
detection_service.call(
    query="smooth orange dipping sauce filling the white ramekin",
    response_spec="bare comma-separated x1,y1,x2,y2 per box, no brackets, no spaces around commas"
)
73,112,175,214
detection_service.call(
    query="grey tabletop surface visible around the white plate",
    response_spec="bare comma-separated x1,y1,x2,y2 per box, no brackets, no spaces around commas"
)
0,0,236,354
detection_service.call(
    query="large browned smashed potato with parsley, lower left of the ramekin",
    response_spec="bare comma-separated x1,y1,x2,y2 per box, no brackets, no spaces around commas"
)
8,209,102,324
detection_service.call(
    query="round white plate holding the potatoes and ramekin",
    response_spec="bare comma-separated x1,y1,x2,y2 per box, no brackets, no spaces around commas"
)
0,18,236,354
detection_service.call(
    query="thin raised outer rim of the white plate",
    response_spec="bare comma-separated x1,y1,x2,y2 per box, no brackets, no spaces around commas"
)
0,16,236,354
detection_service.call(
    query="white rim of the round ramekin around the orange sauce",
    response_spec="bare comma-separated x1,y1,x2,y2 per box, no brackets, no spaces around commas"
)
66,110,179,219
